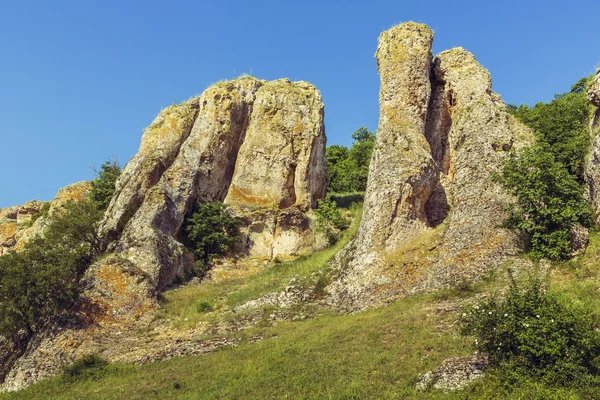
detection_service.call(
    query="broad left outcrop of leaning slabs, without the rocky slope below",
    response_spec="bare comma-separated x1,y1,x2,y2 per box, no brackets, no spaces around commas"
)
101,77,326,290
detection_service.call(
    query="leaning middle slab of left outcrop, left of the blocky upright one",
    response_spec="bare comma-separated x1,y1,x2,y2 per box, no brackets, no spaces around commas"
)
117,77,262,289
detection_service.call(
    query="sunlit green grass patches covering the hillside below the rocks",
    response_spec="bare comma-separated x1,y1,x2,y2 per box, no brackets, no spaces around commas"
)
0,210,600,400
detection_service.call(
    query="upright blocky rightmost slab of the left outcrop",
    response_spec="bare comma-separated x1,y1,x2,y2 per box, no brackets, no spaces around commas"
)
225,79,327,210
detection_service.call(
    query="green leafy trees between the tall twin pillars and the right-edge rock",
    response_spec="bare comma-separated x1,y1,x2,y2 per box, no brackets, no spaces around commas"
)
496,78,591,260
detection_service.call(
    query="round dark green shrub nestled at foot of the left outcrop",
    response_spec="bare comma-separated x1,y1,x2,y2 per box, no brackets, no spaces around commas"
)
183,203,241,277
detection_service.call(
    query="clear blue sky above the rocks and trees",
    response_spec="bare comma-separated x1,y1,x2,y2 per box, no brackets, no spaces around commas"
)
0,0,600,207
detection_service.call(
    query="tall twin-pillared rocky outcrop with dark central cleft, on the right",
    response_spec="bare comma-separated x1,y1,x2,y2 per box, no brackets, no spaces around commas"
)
331,22,532,308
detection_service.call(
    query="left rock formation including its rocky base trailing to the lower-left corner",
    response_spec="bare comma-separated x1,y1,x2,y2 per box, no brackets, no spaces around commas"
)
0,77,327,390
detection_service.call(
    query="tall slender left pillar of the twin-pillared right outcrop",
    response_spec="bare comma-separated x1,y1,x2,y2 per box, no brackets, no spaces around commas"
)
328,23,438,302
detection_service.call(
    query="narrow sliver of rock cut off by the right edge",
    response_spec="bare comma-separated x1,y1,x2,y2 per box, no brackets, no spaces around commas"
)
585,69,600,223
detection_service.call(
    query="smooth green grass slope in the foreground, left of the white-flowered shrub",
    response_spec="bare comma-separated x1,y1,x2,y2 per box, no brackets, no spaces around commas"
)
0,290,469,400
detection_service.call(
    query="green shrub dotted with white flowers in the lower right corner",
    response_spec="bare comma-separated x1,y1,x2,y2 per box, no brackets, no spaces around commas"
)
459,275,600,386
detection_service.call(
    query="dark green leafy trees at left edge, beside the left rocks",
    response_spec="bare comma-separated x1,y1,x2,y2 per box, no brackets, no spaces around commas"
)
0,201,102,338
